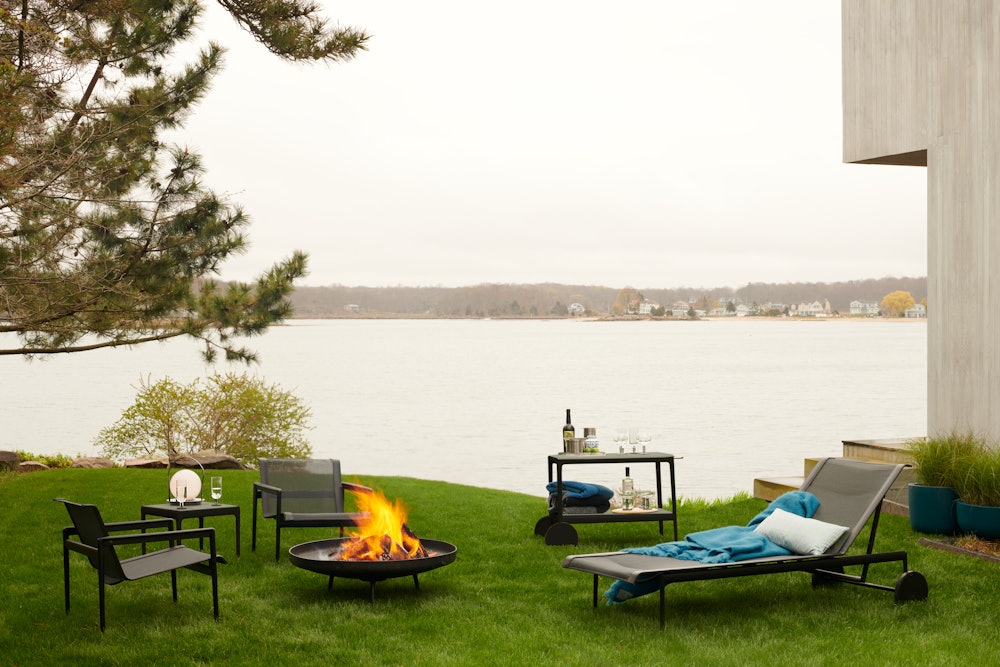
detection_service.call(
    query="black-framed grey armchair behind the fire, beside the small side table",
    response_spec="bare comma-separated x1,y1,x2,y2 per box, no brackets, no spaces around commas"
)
250,459,371,562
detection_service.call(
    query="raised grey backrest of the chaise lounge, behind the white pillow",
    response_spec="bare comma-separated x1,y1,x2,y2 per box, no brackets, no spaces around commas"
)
801,458,906,555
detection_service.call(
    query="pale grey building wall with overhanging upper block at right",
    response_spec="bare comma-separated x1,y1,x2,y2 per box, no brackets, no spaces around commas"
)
842,0,1000,440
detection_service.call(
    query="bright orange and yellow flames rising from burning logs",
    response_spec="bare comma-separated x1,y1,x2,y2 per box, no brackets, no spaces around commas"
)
331,491,427,560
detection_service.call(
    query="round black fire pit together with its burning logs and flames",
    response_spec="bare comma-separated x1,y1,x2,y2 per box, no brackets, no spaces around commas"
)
288,491,458,602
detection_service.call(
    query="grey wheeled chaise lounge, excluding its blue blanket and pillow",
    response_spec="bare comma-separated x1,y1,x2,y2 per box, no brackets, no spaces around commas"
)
563,459,927,630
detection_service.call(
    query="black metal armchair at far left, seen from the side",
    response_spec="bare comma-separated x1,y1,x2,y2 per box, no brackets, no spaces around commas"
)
55,498,225,632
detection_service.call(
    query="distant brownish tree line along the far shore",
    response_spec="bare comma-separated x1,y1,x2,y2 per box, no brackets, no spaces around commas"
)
290,277,927,318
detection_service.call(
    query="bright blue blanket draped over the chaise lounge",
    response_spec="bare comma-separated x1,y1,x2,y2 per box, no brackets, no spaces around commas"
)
604,491,819,604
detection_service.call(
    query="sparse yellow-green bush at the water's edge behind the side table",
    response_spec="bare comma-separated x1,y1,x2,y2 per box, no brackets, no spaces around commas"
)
95,373,312,464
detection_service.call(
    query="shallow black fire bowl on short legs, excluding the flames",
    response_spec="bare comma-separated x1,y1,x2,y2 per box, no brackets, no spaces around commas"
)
288,537,458,600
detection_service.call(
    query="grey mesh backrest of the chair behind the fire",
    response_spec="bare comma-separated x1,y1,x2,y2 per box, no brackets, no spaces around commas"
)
260,459,344,516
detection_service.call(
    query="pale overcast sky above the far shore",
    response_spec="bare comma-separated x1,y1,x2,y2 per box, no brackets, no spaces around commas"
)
178,0,927,289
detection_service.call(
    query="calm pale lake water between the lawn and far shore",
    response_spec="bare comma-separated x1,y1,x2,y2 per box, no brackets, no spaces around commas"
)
0,319,927,498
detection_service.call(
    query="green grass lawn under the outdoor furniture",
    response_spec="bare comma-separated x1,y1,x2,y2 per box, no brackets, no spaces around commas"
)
0,469,1000,667
